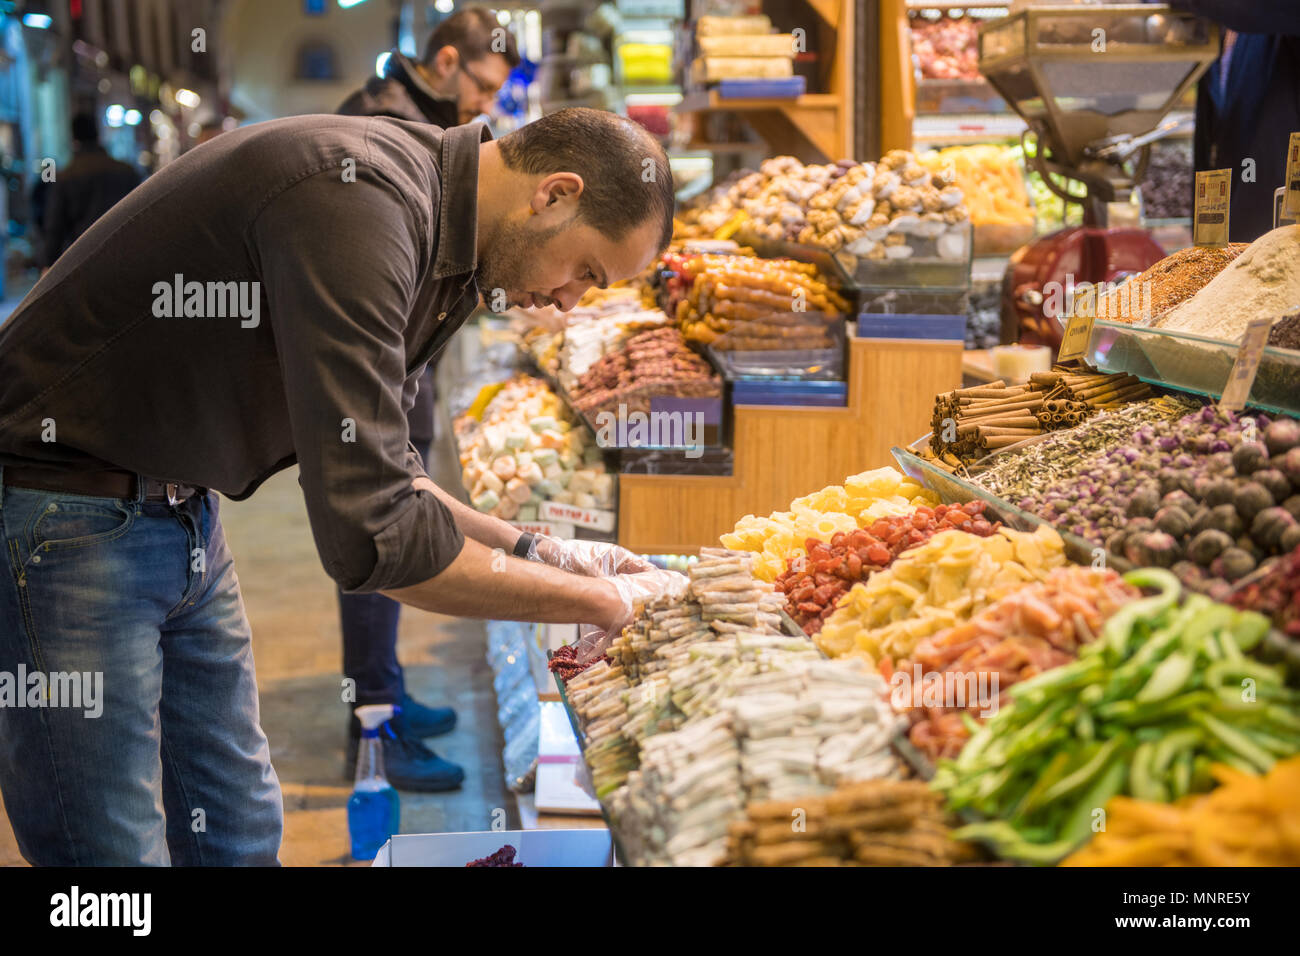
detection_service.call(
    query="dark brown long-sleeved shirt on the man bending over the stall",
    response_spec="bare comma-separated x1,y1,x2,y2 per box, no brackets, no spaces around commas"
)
0,116,489,591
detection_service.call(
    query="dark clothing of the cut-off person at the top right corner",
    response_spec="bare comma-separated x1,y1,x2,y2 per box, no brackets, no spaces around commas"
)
1170,0,1300,242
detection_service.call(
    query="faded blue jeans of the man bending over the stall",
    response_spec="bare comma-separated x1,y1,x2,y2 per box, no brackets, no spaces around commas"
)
0,468,283,866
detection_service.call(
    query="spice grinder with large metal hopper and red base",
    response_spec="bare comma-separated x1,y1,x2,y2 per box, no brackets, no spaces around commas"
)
979,4,1219,349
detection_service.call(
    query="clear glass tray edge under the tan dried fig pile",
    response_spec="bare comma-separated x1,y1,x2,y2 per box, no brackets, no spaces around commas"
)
736,222,975,291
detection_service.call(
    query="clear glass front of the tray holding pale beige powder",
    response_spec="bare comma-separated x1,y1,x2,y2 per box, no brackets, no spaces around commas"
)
1088,319,1300,415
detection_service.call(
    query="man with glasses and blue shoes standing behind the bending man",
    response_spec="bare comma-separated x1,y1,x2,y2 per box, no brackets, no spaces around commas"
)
338,8,519,791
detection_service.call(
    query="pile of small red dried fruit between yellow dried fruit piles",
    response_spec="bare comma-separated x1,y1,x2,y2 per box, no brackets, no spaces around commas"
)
776,501,998,636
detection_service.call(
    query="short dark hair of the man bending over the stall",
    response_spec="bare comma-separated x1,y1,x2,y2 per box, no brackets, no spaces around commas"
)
497,107,673,250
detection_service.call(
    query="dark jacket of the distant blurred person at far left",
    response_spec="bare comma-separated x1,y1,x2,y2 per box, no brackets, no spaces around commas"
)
39,146,140,265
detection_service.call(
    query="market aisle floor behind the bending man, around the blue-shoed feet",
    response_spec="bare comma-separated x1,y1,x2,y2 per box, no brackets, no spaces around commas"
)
0,418,517,866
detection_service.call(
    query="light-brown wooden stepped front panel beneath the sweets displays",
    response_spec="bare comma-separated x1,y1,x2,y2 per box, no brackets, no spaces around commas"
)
619,337,962,554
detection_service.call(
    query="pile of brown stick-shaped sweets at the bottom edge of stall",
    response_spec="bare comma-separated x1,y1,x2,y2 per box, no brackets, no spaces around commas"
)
727,780,969,866
